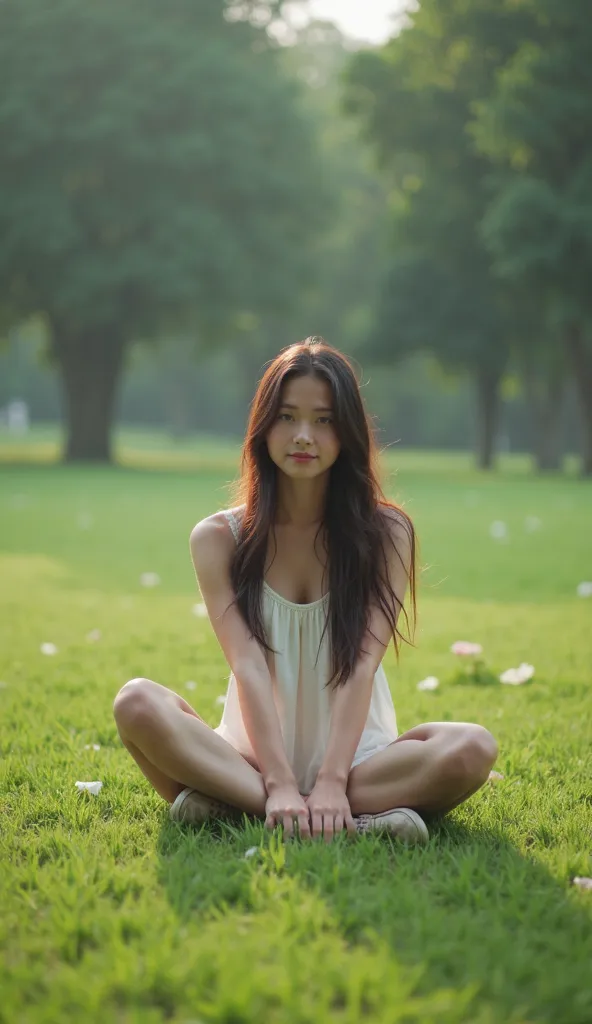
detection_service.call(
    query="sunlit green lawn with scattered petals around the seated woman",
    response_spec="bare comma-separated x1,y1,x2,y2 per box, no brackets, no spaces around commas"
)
0,437,592,1024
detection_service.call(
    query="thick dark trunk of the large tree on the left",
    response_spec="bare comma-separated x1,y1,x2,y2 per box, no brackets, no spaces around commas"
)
53,329,125,462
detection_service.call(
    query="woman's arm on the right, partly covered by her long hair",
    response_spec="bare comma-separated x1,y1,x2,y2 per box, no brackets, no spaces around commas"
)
316,520,412,787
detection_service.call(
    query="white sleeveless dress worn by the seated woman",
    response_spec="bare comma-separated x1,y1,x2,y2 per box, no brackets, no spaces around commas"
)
214,508,398,795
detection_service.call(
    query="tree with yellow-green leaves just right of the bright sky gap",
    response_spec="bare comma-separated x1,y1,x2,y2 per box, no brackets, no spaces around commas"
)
340,0,540,468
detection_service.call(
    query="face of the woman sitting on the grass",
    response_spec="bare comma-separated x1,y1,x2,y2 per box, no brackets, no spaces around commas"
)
266,377,341,479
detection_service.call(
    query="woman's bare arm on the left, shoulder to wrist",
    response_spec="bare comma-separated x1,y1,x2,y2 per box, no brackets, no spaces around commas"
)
189,514,298,793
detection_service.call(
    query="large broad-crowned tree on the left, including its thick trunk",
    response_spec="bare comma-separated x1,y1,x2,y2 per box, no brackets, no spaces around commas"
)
0,0,331,460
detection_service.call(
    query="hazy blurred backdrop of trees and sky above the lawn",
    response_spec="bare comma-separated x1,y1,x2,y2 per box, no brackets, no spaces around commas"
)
0,0,592,475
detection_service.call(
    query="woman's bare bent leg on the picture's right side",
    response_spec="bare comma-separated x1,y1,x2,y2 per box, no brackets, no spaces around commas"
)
347,722,498,815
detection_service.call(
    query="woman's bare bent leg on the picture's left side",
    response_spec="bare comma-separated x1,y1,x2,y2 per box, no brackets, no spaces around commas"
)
114,679,267,817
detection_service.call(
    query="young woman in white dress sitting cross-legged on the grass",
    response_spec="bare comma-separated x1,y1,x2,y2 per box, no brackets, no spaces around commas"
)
115,338,498,843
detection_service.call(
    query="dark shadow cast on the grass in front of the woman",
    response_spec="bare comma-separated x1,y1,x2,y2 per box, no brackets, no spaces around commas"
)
158,816,592,1024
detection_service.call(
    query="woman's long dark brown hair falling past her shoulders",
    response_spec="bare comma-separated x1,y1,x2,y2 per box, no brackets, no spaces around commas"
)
225,337,417,688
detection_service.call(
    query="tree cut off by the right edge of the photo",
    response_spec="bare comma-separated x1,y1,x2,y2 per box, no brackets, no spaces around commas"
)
473,0,592,475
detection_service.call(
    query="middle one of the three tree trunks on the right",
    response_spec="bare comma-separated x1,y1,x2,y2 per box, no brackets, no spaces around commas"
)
522,367,565,472
